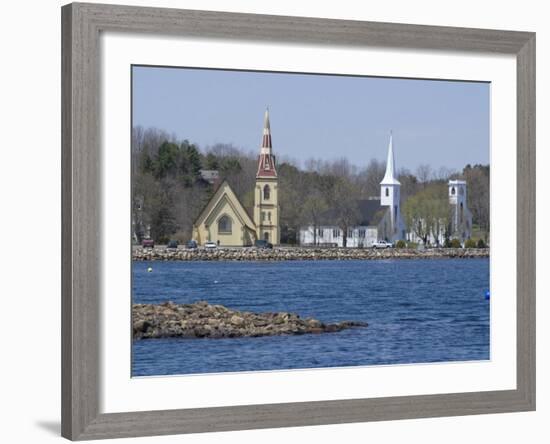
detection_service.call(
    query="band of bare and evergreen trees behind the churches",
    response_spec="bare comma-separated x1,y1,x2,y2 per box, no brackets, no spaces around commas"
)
132,126,489,245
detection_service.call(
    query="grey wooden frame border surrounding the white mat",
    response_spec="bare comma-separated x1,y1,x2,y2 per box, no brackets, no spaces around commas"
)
62,3,535,440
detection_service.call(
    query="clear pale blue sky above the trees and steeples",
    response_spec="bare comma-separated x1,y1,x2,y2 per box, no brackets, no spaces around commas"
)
133,66,490,171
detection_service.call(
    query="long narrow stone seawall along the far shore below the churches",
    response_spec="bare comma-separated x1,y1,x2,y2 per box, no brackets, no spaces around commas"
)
132,247,489,261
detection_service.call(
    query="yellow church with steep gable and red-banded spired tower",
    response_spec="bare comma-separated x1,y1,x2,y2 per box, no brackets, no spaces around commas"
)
193,110,281,247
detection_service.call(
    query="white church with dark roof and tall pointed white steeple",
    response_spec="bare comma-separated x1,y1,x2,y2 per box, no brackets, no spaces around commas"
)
300,135,406,247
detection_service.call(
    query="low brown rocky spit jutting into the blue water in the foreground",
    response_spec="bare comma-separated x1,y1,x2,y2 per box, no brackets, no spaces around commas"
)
132,301,367,339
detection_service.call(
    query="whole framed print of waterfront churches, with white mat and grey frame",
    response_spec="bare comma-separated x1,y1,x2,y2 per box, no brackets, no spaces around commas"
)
62,4,535,439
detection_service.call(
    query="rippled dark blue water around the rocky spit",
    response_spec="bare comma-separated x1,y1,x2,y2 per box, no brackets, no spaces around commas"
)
132,259,490,376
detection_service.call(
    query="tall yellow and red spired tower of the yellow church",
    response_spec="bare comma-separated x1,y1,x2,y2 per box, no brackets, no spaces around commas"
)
254,110,281,245
